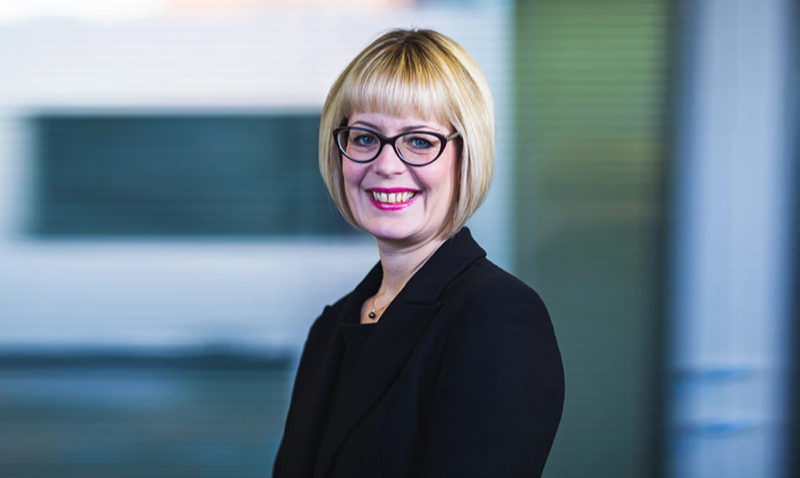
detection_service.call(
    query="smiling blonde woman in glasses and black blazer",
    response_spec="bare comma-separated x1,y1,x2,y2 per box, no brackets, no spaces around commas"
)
274,30,564,478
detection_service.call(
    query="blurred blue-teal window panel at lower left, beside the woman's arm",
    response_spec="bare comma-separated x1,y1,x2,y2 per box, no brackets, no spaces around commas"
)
0,348,294,478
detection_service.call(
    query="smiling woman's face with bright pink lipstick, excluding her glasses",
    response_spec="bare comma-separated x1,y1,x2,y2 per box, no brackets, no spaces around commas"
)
342,113,457,247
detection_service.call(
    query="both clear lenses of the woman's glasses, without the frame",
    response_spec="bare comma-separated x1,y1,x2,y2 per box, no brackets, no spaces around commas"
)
338,129,442,164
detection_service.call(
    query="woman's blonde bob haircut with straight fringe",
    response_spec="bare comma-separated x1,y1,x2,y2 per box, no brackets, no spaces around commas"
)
319,30,495,238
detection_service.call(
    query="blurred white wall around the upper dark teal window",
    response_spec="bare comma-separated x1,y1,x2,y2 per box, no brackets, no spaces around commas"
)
0,7,513,349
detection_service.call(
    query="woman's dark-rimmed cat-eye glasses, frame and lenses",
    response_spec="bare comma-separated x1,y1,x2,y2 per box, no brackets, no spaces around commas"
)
333,126,458,166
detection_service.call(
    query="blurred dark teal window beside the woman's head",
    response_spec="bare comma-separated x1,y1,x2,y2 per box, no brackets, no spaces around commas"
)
31,113,355,236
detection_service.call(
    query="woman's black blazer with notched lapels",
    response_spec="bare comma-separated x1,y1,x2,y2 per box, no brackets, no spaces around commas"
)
273,228,564,478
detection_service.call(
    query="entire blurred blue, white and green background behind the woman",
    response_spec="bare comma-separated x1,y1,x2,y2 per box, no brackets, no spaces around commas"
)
0,0,800,478
